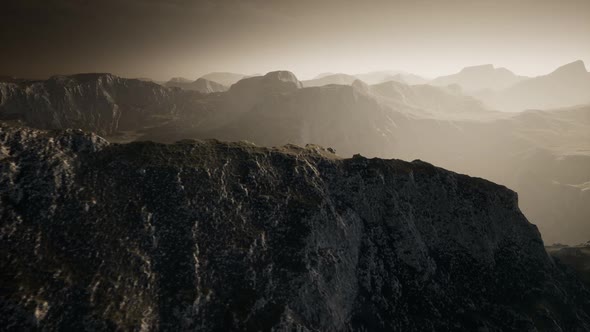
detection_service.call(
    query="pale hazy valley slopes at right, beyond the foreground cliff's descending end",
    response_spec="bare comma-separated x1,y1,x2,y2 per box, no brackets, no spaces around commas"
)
390,106,590,244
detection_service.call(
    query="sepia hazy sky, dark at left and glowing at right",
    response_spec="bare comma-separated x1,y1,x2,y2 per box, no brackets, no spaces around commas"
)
0,0,590,80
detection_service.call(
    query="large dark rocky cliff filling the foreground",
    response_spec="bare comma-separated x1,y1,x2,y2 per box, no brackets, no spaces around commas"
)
0,126,590,331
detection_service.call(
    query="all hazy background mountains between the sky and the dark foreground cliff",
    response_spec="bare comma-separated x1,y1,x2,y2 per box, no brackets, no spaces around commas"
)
0,62,590,244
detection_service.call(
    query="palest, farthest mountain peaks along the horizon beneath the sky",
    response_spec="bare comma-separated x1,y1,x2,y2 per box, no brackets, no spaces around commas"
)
167,60,590,111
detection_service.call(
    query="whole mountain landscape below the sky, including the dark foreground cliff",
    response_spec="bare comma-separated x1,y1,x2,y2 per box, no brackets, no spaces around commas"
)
0,62,590,331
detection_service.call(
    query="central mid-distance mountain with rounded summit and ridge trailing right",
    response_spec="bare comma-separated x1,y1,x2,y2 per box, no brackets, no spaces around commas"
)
150,74,485,156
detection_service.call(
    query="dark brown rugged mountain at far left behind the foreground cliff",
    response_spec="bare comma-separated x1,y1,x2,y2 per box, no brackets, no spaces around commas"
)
0,74,199,134
